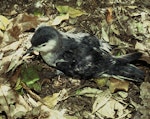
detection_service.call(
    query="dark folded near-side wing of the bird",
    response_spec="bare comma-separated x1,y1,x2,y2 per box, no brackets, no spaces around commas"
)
56,38,113,78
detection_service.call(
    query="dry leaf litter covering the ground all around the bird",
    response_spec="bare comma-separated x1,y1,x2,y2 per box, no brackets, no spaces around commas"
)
0,0,150,119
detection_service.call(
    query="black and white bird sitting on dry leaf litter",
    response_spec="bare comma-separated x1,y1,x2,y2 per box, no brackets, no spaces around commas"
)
29,26,144,82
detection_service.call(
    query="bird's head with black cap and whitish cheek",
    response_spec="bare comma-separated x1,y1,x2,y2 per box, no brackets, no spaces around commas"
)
31,26,61,53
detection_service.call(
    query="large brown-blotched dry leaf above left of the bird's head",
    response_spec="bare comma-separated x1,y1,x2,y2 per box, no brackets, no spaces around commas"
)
0,13,40,47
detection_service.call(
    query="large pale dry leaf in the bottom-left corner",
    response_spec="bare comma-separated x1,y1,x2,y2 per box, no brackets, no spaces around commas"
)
0,84,31,118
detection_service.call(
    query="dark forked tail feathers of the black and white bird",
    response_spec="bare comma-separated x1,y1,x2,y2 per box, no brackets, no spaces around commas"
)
105,52,144,82
